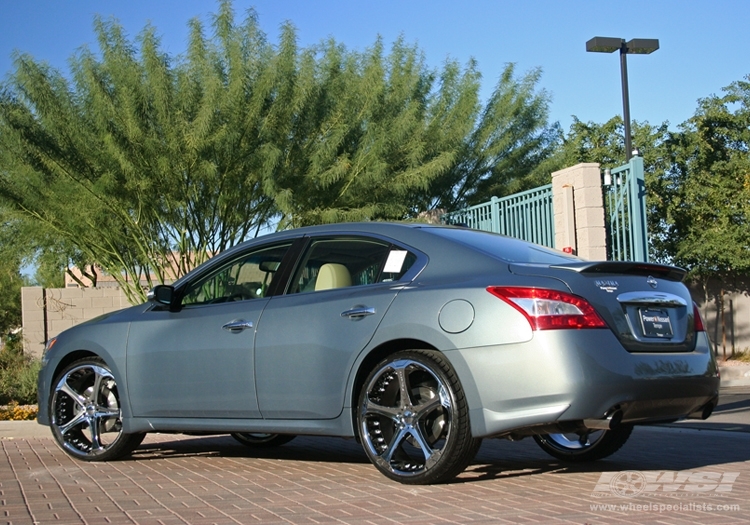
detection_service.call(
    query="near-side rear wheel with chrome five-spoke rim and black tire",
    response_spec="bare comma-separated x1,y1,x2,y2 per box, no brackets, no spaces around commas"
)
357,350,482,485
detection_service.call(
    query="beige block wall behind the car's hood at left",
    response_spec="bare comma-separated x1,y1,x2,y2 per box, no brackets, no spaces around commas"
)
21,286,130,357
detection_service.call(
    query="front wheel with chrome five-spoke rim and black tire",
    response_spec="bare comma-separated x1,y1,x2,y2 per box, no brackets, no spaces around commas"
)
50,357,146,461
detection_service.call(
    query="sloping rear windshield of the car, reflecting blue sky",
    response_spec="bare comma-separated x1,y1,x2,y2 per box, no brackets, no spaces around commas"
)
424,228,581,264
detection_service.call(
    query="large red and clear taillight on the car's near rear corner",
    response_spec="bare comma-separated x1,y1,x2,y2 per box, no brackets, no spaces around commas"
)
487,286,607,330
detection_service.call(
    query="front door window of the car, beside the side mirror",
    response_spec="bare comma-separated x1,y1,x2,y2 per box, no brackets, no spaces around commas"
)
182,244,291,306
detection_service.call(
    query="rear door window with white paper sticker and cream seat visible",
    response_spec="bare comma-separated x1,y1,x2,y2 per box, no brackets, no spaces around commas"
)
290,239,416,293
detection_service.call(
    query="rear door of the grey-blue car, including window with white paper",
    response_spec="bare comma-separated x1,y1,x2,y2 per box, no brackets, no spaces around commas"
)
255,237,416,419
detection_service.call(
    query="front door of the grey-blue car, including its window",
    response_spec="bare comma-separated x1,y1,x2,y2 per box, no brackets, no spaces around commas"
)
127,242,291,418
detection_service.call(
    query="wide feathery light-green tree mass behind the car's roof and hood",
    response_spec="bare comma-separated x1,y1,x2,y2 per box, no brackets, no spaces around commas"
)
0,0,555,301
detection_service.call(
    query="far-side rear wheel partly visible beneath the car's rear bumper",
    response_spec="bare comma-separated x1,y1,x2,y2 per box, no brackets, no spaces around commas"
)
534,425,633,463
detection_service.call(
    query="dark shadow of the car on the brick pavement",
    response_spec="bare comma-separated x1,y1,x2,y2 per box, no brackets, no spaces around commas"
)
130,427,750,483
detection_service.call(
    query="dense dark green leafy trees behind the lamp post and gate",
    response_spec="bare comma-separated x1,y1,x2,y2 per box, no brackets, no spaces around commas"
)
547,81,750,279
